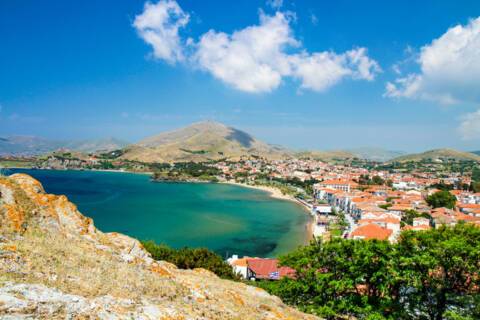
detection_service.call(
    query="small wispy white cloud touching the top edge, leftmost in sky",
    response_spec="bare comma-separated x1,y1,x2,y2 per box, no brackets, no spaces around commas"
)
133,0,189,64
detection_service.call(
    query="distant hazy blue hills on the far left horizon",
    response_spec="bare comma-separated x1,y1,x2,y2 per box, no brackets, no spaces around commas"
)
0,136,128,156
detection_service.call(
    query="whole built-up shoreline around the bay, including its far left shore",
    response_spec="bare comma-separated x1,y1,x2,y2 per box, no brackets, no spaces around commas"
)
2,153,480,280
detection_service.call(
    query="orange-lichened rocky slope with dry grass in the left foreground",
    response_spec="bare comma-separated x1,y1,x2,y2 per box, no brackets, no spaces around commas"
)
0,174,315,320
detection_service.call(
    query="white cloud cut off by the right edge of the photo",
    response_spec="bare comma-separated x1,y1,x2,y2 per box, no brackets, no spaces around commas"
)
385,17,480,104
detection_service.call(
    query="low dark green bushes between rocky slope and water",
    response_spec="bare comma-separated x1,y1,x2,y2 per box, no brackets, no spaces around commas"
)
142,241,238,280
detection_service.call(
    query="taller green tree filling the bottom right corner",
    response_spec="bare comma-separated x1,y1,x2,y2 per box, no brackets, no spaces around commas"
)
397,223,480,320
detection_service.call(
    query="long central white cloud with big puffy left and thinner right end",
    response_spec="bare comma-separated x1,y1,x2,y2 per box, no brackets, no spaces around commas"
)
195,12,380,92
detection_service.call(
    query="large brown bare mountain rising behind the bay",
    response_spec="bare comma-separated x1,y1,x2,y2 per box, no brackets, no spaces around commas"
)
122,121,290,162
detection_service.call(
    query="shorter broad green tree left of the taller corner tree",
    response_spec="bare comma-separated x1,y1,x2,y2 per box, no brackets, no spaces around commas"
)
256,239,398,319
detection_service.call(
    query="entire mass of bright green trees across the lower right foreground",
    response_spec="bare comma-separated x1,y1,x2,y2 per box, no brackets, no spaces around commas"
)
258,223,480,320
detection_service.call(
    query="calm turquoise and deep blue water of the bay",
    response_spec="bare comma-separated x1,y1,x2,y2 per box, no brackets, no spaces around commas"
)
14,170,309,257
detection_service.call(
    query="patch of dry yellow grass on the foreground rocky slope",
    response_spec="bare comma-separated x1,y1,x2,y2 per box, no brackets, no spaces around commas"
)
7,229,186,300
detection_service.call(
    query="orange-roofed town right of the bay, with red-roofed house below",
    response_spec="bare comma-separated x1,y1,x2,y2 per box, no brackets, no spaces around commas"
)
215,159,480,280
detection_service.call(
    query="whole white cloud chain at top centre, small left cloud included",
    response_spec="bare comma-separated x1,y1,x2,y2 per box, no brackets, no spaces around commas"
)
134,0,380,93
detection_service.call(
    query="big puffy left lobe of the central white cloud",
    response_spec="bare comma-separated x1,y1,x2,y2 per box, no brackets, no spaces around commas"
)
194,12,299,92
